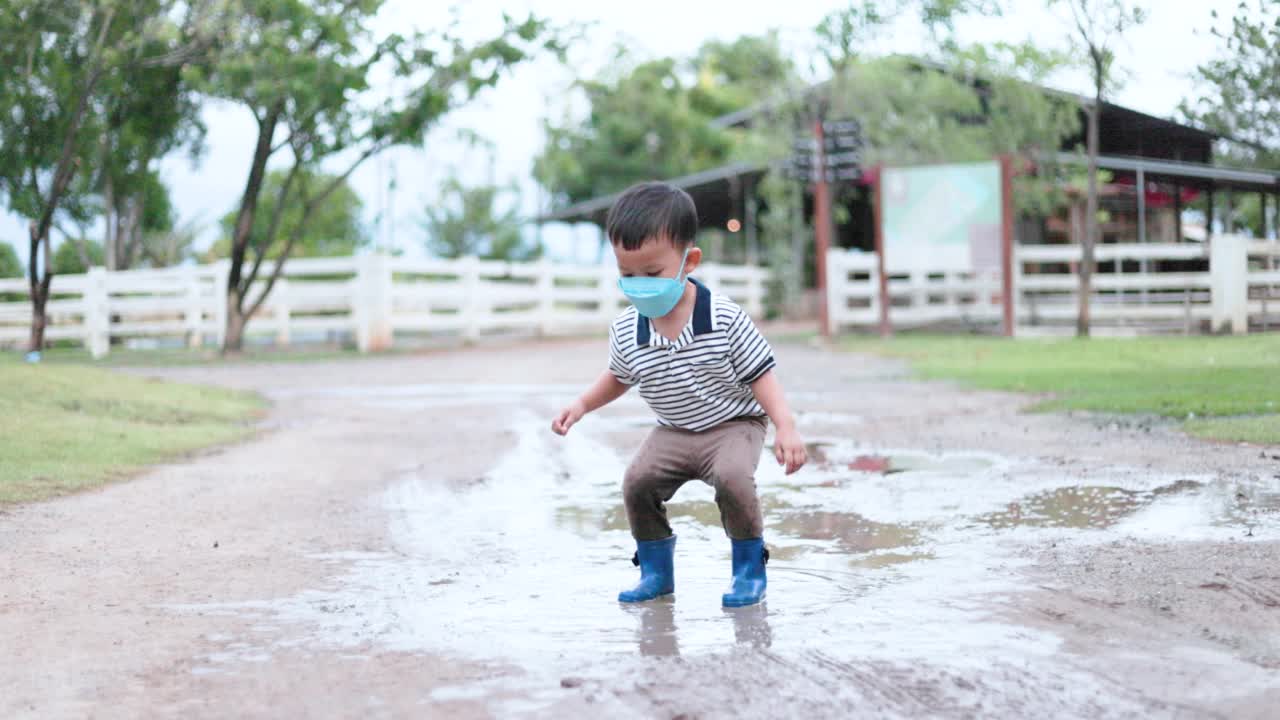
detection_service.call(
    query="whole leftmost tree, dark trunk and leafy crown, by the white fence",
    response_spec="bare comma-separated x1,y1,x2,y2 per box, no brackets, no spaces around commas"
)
0,0,221,350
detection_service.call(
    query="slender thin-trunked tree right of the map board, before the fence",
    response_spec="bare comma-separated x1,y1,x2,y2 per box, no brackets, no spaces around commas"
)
1048,0,1147,337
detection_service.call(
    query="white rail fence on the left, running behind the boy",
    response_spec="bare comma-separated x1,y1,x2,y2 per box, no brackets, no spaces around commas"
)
0,255,767,356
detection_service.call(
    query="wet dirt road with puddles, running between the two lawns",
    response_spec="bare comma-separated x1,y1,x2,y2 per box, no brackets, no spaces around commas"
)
0,341,1280,717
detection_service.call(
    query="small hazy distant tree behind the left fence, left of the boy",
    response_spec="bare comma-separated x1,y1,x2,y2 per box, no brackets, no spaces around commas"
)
422,177,541,261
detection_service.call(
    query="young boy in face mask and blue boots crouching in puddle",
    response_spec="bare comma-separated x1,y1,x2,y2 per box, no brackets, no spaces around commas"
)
552,182,805,607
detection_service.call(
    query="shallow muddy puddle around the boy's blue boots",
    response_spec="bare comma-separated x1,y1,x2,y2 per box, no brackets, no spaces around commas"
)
165,391,1280,714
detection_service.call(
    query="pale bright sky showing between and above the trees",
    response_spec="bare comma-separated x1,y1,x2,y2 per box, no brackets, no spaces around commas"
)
0,0,1236,267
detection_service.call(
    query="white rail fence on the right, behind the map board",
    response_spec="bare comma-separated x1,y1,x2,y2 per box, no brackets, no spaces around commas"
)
827,236,1280,336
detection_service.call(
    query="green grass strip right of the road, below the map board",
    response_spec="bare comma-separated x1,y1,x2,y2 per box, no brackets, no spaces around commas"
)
842,336,1280,443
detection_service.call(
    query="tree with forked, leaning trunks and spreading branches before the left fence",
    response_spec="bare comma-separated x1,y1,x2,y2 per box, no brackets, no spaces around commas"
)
193,0,562,352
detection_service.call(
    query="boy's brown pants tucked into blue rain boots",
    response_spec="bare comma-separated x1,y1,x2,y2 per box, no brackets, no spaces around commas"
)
622,418,768,541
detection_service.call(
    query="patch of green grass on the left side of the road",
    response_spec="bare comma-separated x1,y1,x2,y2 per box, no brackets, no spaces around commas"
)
0,355,265,506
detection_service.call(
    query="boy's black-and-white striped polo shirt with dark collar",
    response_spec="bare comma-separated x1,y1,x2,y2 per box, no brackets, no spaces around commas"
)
609,278,774,430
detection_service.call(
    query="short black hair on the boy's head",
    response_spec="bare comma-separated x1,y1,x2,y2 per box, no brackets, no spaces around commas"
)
605,182,698,250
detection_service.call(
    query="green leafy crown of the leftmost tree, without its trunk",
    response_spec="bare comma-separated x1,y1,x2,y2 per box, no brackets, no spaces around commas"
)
0,0,218,238
